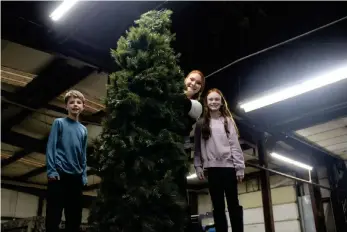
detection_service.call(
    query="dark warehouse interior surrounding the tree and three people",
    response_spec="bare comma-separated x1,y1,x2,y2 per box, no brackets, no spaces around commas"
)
1,1,347,232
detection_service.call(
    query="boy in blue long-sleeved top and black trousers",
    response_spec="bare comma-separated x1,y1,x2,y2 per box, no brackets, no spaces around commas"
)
46,90,87,232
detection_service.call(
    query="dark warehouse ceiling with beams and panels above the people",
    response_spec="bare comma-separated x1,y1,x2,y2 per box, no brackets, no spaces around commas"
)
1,2,347,192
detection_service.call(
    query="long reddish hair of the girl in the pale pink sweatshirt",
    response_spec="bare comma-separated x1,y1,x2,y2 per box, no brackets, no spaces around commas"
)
201,88,239,140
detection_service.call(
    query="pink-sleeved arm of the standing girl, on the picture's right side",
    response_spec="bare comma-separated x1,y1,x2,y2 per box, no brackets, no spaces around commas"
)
228,118,245,176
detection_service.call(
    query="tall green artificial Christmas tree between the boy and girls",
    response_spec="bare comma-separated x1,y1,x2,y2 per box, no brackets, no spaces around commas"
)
89,10,191,232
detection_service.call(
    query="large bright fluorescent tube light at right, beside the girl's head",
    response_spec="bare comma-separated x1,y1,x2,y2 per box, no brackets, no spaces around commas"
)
240,65,347,112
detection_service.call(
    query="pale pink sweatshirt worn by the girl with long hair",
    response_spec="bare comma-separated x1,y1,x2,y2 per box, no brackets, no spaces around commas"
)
194,117,245,176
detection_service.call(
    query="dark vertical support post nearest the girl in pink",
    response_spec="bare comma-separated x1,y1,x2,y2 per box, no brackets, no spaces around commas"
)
257,133,275,232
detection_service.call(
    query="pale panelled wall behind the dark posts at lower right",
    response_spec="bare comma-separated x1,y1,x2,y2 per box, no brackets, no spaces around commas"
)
198,175,301,232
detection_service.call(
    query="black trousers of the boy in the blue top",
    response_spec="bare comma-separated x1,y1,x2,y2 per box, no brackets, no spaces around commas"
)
46,173,83,232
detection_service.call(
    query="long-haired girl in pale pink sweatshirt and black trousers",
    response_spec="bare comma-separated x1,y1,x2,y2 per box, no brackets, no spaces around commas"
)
194,89,245,232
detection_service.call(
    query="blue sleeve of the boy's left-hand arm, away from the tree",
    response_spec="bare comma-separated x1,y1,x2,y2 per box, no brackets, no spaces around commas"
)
46,119,60,177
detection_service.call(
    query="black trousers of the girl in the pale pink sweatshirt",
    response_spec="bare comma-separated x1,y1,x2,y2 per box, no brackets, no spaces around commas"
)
207,168,243,232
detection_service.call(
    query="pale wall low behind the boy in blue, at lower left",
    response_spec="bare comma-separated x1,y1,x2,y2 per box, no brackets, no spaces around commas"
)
1,188,89,223
